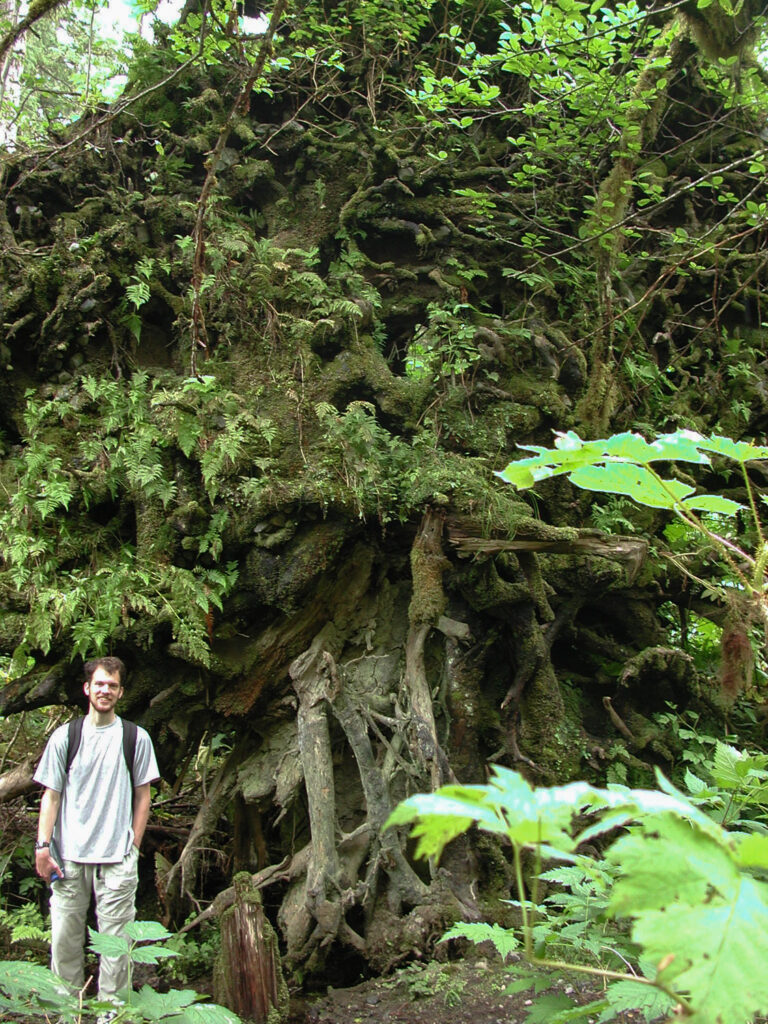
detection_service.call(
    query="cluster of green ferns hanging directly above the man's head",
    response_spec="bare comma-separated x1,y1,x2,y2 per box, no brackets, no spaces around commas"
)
0,374,249,670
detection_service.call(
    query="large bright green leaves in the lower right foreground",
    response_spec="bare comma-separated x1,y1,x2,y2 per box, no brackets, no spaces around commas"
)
388,767,768,1024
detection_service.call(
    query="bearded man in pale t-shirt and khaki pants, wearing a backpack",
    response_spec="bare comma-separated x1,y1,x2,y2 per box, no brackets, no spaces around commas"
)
35,657,159,999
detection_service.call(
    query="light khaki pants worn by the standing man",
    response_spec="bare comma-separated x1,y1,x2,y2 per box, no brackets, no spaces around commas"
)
50,845,138,999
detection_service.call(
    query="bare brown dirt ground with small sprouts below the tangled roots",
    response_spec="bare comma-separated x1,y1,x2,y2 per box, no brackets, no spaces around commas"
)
282,956,642,1024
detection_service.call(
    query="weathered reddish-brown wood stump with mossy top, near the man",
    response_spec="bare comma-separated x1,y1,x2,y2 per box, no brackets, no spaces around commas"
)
213,871,288,1024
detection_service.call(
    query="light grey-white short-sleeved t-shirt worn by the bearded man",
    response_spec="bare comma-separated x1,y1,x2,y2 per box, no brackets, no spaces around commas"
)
35,718,160,864
